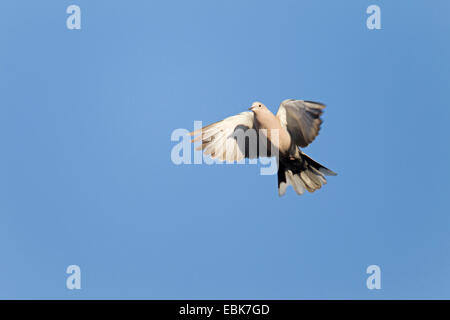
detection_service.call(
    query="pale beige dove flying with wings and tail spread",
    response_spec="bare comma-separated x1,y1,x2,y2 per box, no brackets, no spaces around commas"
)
190,99,336,196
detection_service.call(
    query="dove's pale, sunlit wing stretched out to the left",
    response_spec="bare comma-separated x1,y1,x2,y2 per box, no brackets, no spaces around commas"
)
190,112,257,162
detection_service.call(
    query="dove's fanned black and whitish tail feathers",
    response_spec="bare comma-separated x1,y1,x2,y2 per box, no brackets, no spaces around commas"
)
278,152,336,197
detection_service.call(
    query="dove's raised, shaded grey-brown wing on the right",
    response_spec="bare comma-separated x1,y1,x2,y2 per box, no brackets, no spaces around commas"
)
277,99,325,148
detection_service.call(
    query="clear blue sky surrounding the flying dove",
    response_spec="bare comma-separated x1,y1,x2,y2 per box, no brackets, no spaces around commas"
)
0,0,450,299
